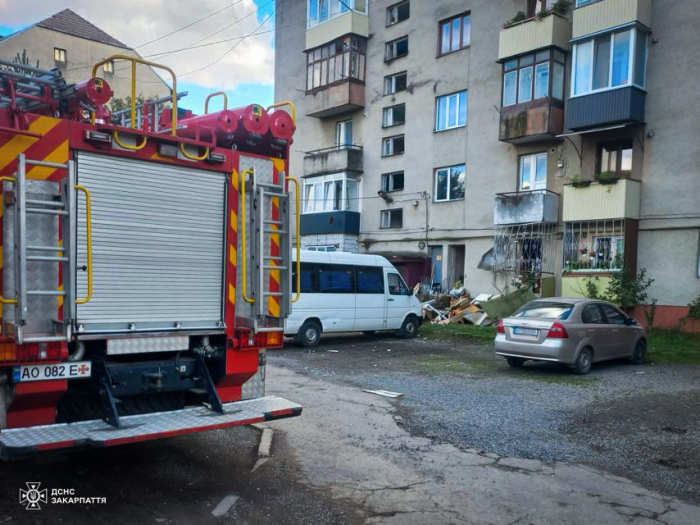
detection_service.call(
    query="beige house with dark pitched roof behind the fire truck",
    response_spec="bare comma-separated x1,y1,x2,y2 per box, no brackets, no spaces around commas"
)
0,9,170,99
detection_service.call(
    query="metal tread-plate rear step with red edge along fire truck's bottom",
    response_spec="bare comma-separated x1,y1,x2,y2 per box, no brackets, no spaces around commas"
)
0,396,301,459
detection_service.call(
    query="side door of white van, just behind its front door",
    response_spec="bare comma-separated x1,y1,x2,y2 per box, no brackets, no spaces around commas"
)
355,266,387,332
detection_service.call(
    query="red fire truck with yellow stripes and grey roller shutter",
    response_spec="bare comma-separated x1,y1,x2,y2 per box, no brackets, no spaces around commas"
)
0,55,301,459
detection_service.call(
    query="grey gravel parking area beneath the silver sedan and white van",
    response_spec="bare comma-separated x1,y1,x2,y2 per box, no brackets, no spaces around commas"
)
268,335,700,502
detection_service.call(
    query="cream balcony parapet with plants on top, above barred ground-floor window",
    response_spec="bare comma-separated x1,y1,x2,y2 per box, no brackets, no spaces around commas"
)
563,179,642,222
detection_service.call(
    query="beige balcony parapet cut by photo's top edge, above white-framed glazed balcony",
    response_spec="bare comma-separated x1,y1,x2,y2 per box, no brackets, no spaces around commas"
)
572,0,652,39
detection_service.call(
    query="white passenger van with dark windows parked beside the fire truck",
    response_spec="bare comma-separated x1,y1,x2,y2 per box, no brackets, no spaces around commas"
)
285,251,422,346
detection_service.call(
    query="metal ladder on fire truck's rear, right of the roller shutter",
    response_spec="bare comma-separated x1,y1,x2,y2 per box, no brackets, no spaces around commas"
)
241,169,292,332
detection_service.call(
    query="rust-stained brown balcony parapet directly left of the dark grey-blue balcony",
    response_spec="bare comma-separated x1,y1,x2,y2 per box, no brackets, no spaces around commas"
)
498,98,564,144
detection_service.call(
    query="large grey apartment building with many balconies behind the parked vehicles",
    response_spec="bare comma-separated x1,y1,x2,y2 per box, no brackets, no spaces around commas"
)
275,0,700,326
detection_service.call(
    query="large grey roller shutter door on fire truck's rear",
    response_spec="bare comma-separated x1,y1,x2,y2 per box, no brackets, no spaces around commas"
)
77,153,226,333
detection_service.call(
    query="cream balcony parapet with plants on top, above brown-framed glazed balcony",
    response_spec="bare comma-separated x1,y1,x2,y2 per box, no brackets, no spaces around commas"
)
498,13,571,60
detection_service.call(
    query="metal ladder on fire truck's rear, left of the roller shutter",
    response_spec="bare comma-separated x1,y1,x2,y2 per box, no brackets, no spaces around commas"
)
2,154,84,344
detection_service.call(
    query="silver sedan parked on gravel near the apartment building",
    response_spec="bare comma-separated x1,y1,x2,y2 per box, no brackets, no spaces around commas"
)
496,298,647,375
